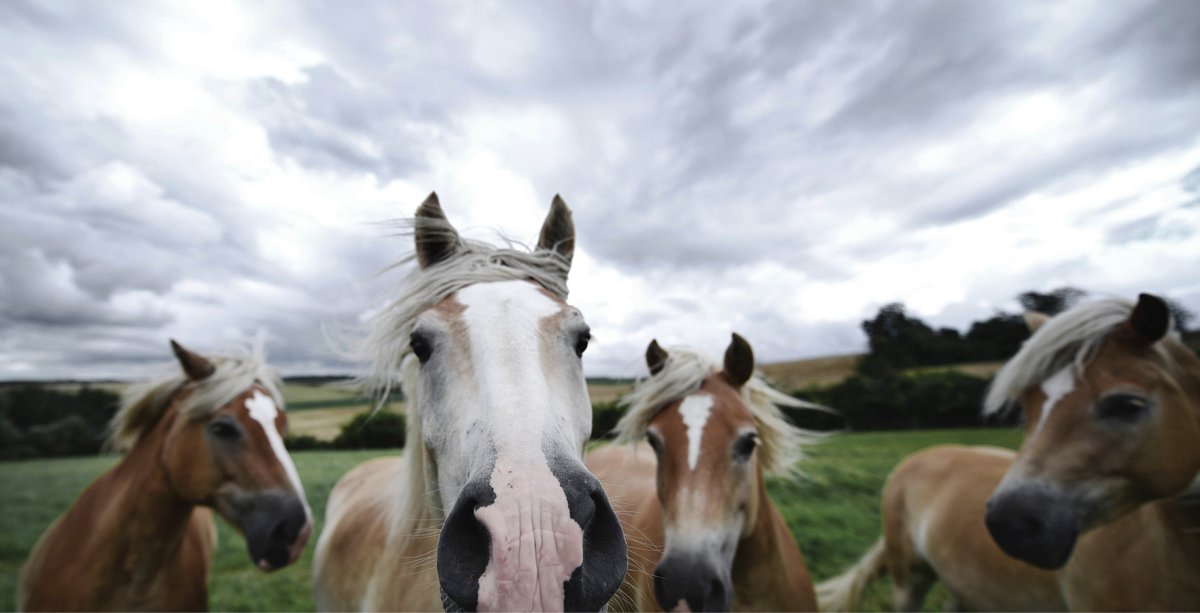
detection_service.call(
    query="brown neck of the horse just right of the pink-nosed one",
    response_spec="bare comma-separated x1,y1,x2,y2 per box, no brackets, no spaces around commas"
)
733,475,815,611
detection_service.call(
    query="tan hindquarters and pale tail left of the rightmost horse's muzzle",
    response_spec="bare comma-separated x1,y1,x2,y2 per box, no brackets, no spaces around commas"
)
817,445,1066,612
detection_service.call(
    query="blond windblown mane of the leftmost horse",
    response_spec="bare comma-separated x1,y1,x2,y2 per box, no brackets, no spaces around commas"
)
108,347,283,451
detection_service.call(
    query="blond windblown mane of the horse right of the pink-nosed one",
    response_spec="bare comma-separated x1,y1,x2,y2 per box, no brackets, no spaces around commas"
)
613,347,828,475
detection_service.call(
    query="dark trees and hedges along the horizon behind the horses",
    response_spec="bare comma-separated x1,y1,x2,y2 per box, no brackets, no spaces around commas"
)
0,287,1200,459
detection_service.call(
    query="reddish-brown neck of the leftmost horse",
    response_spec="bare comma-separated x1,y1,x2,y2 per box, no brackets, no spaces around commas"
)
88,415,194,599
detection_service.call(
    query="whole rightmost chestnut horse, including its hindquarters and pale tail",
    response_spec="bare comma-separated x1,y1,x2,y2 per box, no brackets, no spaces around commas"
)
818,294,1200,611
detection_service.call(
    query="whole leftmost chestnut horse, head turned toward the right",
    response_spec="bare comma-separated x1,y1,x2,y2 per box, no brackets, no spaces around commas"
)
17,341,312,611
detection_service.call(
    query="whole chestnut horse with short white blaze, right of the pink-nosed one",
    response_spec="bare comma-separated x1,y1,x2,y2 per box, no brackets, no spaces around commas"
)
588,333,816,611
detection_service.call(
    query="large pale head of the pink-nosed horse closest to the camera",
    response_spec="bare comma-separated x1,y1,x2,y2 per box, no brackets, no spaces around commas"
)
407,196,626,611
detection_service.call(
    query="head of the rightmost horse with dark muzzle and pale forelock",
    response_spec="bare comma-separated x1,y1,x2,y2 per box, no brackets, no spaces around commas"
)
986,294,1200,569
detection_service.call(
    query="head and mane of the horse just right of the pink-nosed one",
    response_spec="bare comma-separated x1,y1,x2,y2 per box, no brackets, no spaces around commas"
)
617,333,814,611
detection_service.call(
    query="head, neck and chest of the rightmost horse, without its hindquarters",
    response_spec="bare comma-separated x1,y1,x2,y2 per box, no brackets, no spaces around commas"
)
985,294,1200,611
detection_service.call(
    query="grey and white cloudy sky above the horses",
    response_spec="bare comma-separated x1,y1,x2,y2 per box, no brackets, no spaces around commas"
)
0,0,1200,379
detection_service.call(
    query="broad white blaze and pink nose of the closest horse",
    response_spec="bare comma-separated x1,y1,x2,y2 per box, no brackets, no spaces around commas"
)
444,281,586,611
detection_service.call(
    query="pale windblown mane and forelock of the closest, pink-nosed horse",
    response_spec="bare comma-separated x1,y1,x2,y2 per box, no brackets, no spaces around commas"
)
349,225,570,542
